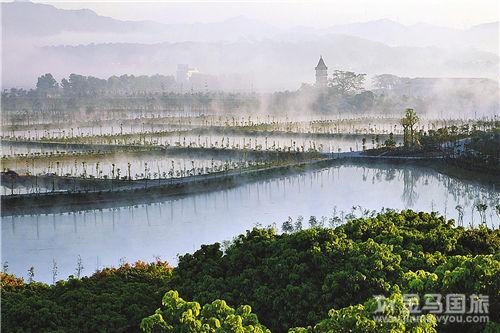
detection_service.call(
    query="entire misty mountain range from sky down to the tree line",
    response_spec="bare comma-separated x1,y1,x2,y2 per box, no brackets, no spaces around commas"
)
1,2,499,91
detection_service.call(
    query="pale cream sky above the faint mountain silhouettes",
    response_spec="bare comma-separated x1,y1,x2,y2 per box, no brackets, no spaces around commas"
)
35,0,500,28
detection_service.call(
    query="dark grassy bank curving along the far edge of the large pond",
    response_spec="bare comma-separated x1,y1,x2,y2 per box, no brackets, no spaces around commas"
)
1,153,500,216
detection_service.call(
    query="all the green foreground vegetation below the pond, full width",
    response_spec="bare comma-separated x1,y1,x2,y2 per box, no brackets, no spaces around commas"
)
2,210,500,333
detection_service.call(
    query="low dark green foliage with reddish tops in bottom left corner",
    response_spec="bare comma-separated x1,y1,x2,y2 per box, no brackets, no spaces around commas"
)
1,262,172,332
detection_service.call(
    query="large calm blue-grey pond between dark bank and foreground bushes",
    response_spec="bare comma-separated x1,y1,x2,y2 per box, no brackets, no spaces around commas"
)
2,163,500,282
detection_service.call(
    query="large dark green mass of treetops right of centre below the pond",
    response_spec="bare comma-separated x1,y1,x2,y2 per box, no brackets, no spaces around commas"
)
172,211,500,332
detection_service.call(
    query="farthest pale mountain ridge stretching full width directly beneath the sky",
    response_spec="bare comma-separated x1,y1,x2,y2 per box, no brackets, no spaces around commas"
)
1,2,499,53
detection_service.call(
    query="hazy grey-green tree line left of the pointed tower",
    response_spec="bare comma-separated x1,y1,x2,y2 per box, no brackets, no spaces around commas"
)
1,73,260,122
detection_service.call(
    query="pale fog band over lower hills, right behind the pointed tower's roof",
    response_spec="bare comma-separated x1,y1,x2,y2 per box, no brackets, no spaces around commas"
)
2,35,499,92
